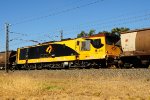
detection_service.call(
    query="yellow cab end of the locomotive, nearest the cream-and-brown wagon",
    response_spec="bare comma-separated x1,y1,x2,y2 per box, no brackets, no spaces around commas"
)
79,34,121,67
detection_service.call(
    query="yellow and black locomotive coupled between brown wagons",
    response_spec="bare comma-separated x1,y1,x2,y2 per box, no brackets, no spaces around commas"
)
16,34,121,69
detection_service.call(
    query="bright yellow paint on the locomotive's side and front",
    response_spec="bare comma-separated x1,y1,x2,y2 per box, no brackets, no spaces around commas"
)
17,36,121,64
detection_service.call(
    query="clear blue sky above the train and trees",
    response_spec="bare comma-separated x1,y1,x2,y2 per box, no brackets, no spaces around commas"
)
0,0,150,51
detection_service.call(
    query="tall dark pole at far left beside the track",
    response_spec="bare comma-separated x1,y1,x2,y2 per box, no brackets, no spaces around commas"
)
5,23,9,73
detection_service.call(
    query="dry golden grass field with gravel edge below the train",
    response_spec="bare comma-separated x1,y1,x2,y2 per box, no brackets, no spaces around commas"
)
0,69,150,100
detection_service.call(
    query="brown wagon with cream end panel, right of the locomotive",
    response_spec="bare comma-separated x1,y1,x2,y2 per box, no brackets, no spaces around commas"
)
119,29,150,68
